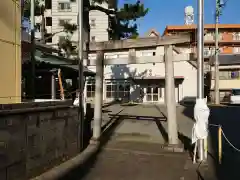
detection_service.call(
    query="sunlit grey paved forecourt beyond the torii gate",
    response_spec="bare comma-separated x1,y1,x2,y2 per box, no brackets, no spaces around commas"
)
100,104,194,144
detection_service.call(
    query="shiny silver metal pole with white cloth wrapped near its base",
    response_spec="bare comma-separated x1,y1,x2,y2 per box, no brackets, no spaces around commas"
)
197,0,204,161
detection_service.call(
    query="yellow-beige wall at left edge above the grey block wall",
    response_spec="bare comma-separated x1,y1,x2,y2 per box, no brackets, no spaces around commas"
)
0,0,21,104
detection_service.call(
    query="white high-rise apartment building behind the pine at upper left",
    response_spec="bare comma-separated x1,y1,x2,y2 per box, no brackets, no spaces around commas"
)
35,0,114,46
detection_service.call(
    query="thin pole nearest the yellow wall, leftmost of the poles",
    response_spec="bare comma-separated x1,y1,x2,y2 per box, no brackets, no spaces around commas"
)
30,0,36,100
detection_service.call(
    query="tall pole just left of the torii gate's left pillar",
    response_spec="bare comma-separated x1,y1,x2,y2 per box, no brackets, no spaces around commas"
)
78,0,84,151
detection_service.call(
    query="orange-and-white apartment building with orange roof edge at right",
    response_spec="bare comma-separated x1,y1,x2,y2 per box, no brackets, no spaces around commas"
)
163,24,240,57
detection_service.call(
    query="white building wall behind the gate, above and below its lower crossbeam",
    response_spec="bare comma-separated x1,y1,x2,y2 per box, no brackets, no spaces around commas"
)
85,46,197,103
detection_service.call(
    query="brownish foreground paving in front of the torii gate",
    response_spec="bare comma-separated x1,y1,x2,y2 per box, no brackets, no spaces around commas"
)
63,141,202,180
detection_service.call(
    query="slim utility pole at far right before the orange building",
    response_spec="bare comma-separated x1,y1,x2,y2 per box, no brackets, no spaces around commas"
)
214,0,224,104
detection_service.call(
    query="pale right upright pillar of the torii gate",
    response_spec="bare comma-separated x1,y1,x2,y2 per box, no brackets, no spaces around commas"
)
164,45,178,145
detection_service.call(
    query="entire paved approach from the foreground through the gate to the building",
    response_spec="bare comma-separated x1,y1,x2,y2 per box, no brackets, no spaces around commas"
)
63,104,215,180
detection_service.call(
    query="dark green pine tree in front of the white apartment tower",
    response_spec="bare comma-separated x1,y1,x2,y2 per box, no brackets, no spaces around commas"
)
23,0,148,58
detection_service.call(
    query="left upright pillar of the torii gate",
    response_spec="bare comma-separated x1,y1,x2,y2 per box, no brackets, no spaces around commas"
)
93,51,104,141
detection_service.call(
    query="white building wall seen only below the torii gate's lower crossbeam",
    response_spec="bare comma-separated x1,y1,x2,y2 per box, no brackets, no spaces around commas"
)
85,61,197,102
